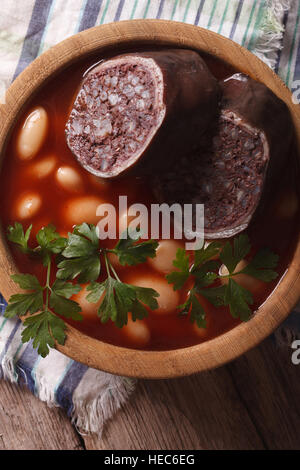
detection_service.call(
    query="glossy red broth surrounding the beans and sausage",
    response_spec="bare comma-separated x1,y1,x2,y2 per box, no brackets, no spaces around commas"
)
0,52,298,350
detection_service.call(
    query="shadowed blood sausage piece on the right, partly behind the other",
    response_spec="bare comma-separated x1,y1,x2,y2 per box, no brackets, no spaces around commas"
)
155,74,293,239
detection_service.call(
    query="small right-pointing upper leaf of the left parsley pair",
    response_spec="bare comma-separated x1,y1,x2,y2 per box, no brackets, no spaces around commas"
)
111,229,158,266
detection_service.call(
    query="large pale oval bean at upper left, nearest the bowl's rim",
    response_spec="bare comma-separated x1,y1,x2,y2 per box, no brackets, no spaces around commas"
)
17,106,48,160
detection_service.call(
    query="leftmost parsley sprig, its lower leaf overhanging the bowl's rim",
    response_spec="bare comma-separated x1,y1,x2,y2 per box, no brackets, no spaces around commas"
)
5,223,82,357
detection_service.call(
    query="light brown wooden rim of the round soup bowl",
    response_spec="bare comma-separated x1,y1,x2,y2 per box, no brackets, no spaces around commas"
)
0,20,300,378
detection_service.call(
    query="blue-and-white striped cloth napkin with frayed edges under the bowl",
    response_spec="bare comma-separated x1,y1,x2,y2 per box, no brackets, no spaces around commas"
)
0,0,300,434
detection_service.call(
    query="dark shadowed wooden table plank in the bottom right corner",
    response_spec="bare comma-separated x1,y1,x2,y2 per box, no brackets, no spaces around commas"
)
228,339,300,450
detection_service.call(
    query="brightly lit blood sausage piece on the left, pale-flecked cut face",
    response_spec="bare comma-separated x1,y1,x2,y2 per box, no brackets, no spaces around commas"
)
66,49,219,178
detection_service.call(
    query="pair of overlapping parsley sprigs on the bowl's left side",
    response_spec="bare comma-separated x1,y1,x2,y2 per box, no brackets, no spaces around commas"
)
5,222,158,357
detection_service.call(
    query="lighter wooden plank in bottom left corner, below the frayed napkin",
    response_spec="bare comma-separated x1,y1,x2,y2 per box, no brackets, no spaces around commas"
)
0,380,84,450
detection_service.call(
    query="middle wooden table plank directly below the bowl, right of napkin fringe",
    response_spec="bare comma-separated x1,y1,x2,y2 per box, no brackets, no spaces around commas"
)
85,374,264,450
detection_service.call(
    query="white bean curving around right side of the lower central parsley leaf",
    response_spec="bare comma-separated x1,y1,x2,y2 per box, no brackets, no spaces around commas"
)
130,275,179,314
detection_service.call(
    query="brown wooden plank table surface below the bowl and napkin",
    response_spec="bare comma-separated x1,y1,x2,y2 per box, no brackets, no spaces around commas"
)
0,338,300,450
